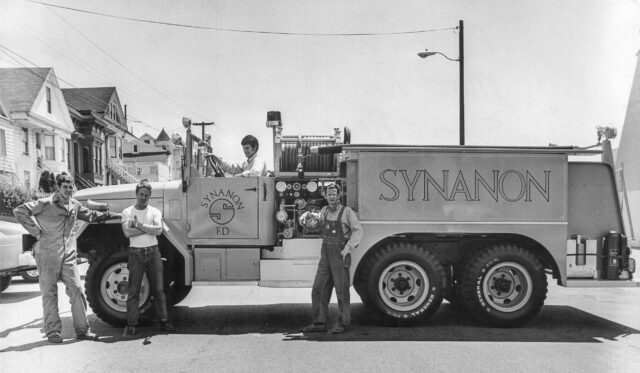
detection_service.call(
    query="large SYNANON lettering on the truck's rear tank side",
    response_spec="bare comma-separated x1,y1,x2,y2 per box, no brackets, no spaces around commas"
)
378,169,551,202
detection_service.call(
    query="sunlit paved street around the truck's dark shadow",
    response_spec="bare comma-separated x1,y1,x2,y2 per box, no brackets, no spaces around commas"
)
0,262,640,373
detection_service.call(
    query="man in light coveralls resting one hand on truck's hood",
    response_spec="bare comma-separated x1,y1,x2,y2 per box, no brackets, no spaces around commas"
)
13,173,120,343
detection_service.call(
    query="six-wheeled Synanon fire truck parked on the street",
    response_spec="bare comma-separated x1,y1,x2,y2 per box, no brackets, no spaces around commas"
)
67,112,639,327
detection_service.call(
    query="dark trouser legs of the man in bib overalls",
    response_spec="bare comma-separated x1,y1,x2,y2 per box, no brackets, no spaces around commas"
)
311,244,351,326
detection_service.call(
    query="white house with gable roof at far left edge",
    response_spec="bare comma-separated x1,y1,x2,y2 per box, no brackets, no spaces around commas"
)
0,67,74,190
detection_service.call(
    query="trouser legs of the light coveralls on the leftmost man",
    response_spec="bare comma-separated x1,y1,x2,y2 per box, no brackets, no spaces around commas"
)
35,249,89,336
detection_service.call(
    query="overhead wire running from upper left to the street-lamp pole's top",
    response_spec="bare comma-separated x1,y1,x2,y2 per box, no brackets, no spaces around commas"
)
26,0,456,37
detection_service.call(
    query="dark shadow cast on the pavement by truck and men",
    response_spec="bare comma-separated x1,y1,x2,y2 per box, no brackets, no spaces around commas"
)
0,303,640,352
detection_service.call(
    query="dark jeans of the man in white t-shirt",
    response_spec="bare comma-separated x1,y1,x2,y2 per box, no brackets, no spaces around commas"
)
127,245,167,325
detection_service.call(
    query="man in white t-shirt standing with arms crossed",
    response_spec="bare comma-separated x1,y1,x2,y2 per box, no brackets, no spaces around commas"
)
122,180,175,336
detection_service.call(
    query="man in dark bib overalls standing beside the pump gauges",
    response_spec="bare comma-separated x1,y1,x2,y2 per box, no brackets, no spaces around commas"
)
302,184,362,333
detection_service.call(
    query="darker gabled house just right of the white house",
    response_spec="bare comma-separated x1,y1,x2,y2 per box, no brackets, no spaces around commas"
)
62,87,136,189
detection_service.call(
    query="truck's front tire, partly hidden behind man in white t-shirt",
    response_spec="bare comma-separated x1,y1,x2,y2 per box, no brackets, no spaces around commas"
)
84,251,153,326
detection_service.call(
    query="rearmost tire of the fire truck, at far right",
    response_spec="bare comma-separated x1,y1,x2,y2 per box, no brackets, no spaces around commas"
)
461,245,547,327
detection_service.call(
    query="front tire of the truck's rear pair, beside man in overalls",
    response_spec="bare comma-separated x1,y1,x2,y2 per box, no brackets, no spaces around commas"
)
362,242,446,322
